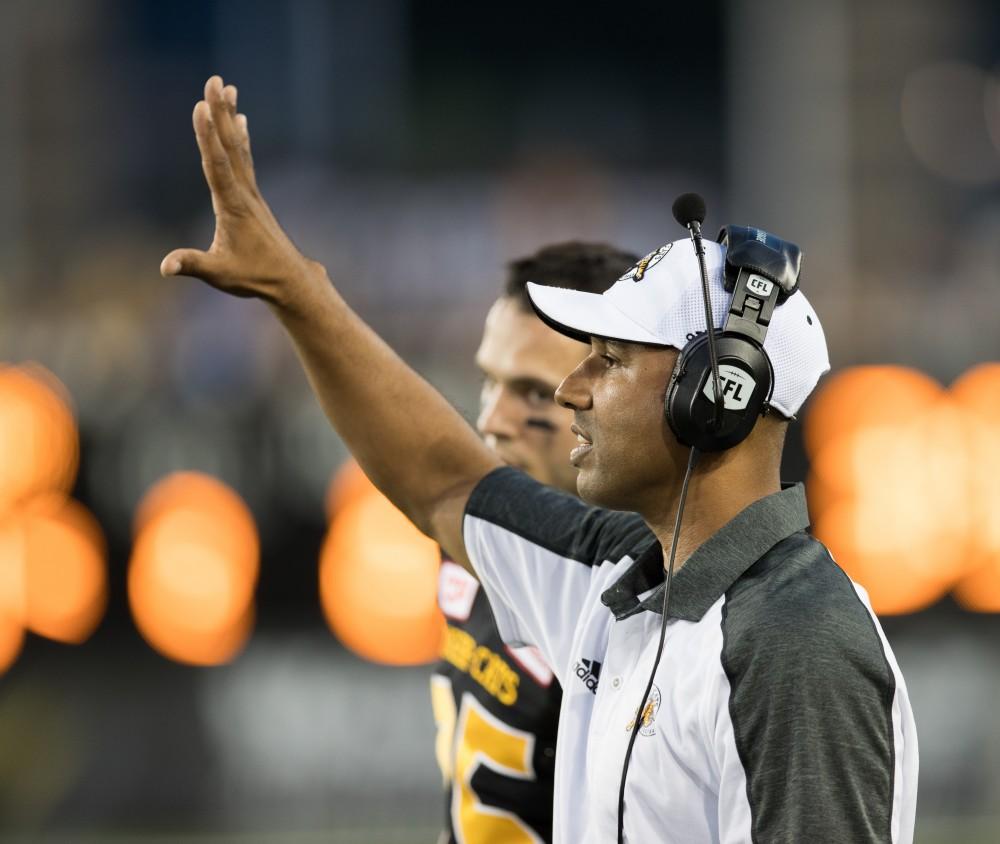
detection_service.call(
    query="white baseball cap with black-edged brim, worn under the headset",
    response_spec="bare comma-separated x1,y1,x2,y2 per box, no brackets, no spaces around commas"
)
528,238,830,418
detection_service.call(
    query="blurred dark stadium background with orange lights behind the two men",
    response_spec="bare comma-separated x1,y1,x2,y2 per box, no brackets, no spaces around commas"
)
0,0,1000,844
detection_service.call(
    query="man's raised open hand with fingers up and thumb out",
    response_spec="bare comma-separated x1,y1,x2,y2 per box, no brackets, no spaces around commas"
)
160,76,325,302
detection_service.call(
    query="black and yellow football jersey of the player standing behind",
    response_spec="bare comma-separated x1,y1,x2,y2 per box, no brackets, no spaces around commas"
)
431,560,562,844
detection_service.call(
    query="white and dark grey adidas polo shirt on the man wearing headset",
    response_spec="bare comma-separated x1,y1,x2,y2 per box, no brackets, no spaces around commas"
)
464,468,917,844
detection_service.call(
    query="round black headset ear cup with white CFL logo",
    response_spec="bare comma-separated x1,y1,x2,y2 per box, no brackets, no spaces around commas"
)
664,331,774,452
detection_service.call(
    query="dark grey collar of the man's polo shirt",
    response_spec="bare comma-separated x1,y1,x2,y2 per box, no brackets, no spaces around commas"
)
601,484,809,621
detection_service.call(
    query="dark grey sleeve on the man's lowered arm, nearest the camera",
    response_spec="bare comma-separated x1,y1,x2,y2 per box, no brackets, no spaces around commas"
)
722,533,896,844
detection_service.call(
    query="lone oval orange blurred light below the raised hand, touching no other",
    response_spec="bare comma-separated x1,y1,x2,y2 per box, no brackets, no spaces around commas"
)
128,472,260,665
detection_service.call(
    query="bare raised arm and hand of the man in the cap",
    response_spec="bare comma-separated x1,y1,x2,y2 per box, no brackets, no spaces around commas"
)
160,76,500,568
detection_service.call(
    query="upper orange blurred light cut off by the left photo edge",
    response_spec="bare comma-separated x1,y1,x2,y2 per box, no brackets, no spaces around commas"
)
0,364,79,512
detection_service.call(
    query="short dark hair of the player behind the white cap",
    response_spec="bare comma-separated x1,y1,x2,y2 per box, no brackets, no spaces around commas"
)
503,240,639,311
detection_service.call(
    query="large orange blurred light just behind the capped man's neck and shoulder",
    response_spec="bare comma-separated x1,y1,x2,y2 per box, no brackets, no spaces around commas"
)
804,366,973,614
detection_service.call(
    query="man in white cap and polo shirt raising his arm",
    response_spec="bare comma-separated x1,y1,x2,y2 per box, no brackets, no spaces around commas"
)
161,77,917,844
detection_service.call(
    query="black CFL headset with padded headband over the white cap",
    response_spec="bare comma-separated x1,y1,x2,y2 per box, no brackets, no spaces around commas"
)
664,226,802,452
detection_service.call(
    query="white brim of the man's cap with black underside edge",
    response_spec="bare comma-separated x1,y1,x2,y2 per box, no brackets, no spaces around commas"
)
527,281,666,346
